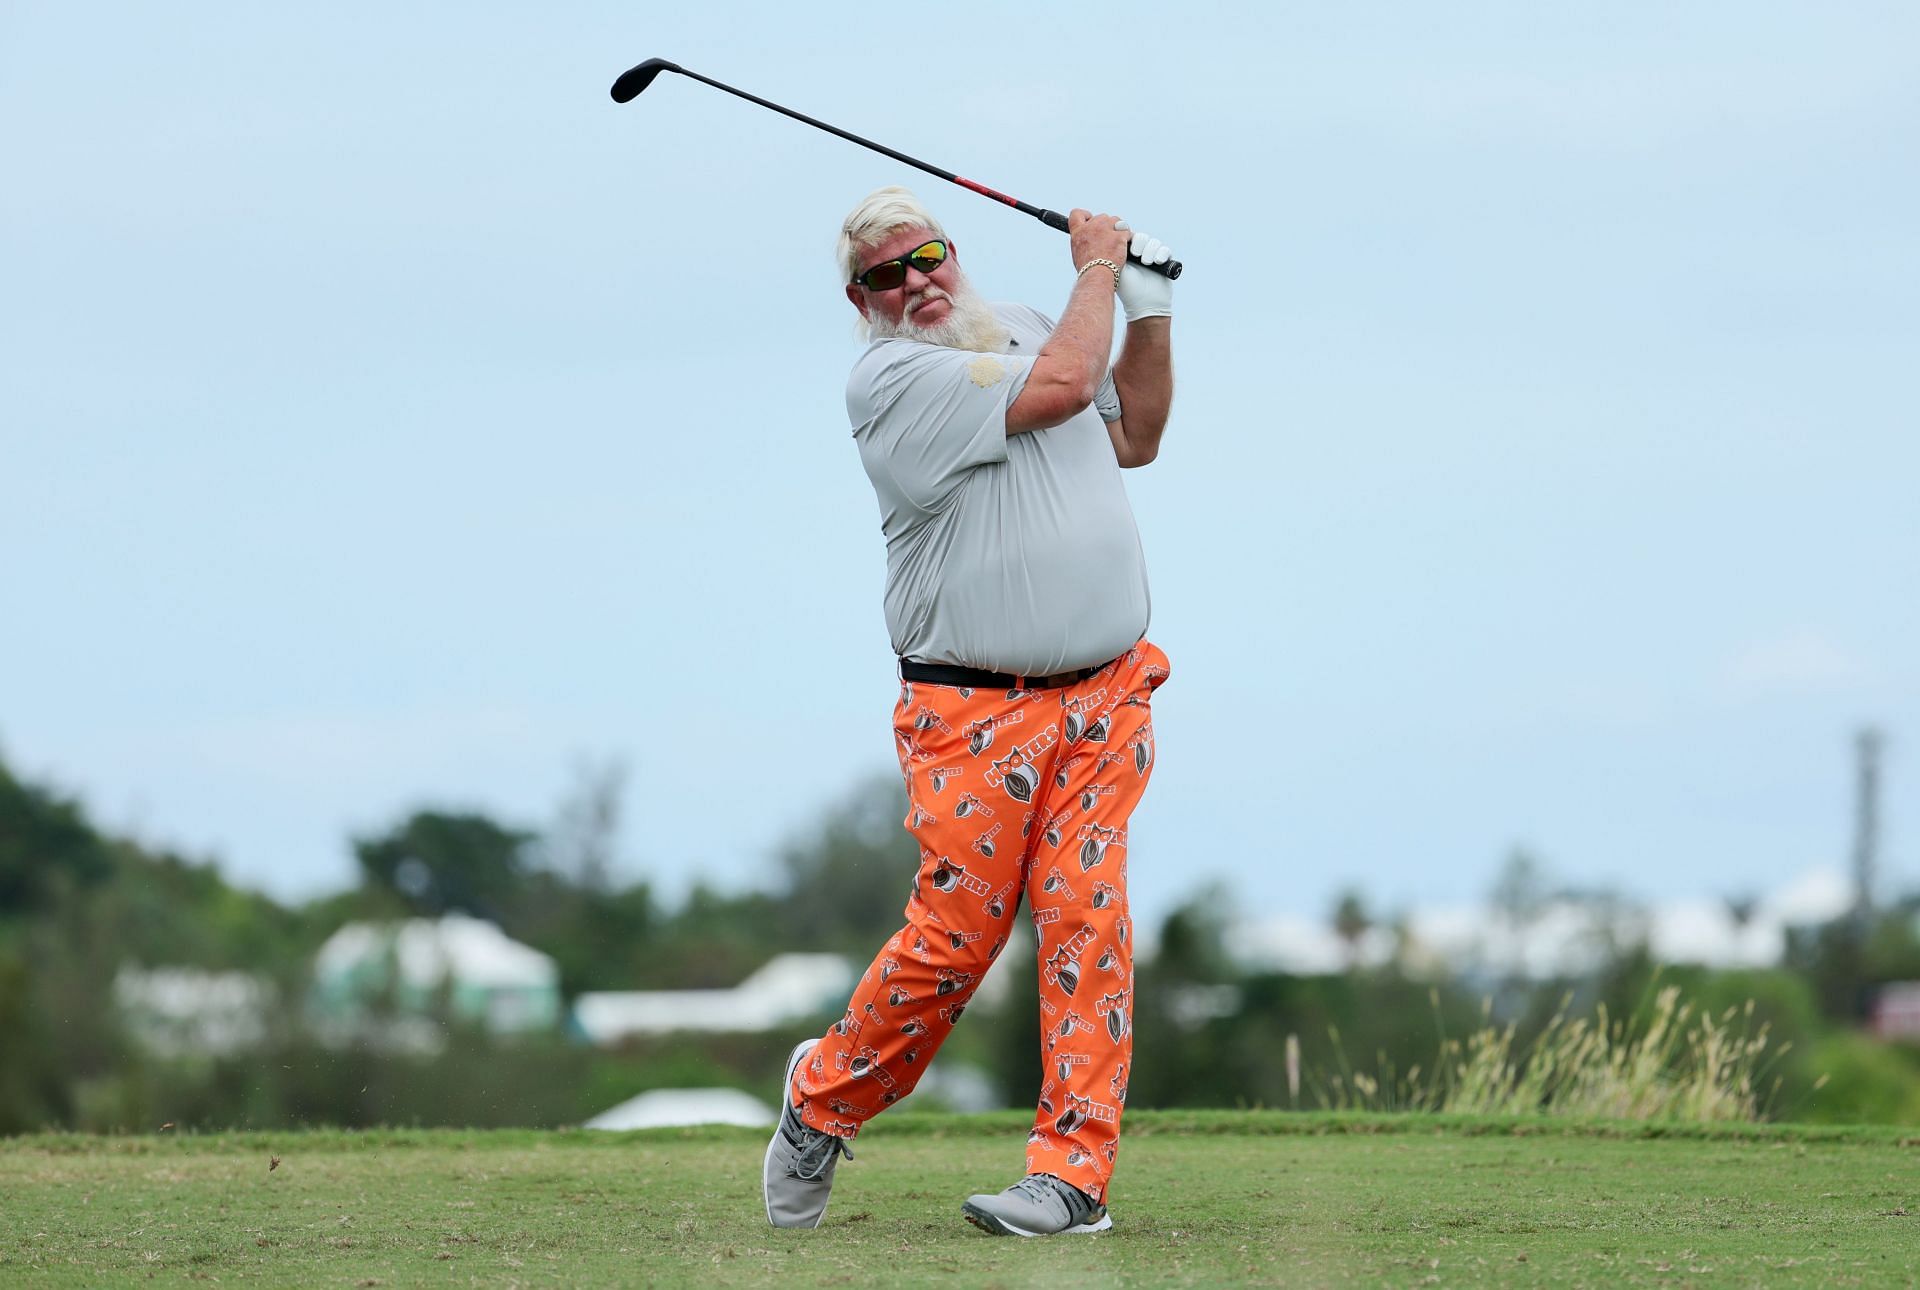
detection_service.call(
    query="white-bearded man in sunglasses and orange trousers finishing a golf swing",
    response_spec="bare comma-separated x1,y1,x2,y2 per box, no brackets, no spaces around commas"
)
762,188,1173,1236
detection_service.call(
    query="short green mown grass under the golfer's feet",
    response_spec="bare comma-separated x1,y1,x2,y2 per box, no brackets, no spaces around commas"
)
0,1111,1920,1286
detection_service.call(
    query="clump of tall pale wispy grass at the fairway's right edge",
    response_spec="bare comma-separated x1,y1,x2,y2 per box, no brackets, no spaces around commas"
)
1313,985,1826,1121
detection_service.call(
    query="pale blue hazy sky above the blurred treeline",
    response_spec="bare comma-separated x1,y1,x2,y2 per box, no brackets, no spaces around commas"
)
0,0,1920,936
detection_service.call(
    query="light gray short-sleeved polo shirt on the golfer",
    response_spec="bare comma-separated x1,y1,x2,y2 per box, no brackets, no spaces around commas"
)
847,303,1148,676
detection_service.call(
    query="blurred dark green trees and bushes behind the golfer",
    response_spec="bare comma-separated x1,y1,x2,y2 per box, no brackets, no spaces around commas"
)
0,764,1920,1133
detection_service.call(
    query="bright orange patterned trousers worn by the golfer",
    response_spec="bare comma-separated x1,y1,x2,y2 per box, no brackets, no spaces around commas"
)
795,641,1167,1200
